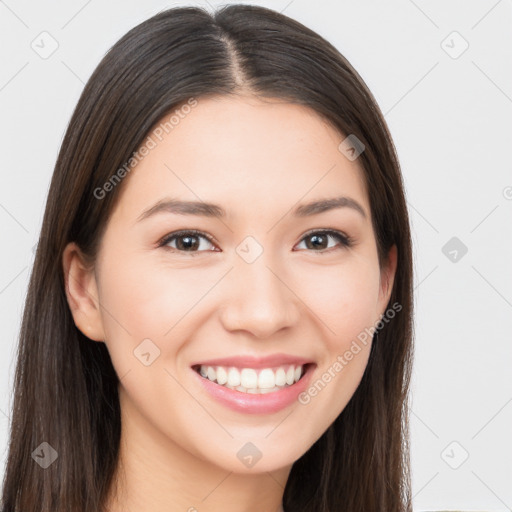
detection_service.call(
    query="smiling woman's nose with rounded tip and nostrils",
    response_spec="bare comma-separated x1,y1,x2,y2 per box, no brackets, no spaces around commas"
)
220,256,301,339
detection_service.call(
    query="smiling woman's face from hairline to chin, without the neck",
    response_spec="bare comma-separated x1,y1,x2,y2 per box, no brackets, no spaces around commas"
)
67,97,396,473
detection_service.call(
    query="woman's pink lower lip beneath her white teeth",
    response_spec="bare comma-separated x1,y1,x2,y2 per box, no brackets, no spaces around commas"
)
192,363,315,414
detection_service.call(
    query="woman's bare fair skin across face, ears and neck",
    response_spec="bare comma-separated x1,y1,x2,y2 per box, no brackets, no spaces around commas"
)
63,93,396,512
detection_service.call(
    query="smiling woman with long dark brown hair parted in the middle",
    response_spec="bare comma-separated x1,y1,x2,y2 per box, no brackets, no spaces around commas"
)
2,5,413,512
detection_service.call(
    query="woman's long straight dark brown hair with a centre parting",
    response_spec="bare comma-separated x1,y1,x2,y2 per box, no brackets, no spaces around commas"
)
1,5,413,512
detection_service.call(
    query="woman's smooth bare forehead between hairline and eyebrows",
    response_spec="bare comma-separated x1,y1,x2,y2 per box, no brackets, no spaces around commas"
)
113,96,369,224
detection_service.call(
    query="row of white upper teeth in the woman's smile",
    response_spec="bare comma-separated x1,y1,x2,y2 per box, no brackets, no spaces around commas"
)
199,365,302,393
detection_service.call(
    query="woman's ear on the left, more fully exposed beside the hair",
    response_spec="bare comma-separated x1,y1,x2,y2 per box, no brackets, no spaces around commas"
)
62,242,105,341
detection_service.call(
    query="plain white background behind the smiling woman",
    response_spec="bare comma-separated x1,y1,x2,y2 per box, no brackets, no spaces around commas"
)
0,0,512,512
